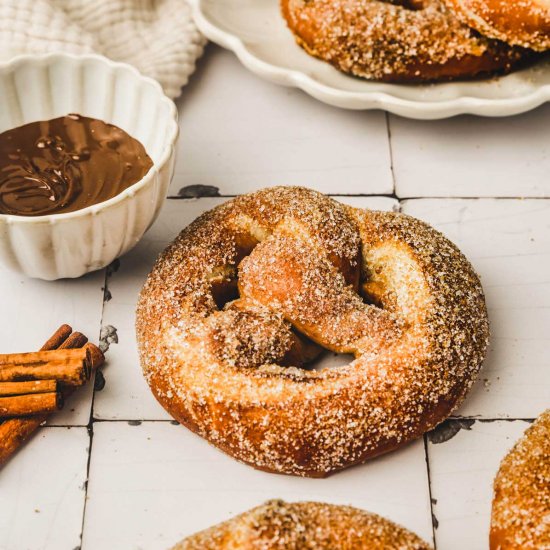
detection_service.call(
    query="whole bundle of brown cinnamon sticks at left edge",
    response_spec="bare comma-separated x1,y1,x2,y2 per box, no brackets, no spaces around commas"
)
0,325,105,467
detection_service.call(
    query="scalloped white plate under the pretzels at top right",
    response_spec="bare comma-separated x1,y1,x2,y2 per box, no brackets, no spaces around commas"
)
190,0,550,119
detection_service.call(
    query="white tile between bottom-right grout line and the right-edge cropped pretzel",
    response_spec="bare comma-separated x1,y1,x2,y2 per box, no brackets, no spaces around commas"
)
428,420,532,550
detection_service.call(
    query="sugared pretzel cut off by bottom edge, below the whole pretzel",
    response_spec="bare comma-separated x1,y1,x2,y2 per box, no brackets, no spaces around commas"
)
172,500,430,550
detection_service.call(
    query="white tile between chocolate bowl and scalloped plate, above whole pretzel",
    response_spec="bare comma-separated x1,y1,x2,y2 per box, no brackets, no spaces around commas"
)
171,45,393,195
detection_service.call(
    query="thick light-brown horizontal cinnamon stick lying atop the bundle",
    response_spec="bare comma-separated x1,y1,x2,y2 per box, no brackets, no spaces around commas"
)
0,348,91,386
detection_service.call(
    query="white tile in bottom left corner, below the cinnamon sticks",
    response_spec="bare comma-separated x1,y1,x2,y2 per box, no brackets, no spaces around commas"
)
0,428,90,550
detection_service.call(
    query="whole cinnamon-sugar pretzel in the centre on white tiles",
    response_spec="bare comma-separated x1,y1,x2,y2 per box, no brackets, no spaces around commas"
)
137,187,488,477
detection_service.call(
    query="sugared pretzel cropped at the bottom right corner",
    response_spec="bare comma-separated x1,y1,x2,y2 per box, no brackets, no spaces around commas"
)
490,409,550,550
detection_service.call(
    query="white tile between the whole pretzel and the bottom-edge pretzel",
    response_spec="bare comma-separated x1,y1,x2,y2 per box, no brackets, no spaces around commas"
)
83,422,432,550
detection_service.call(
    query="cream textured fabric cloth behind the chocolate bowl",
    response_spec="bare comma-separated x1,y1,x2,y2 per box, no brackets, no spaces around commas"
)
0,0,205,98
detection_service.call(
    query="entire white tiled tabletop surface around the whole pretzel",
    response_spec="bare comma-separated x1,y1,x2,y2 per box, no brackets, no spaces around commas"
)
0,46,550,550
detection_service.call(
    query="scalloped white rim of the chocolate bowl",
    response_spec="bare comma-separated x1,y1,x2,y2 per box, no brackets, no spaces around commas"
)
0,52,179,224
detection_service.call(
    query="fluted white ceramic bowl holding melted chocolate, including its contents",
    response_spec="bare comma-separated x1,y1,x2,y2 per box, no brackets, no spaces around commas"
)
0,54,178,280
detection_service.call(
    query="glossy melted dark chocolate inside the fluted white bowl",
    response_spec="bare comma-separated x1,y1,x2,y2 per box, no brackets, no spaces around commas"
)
0,114,153,216
